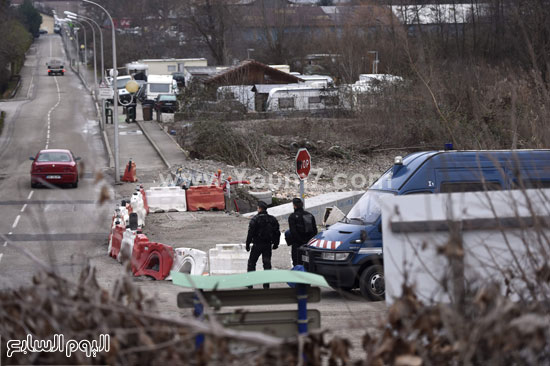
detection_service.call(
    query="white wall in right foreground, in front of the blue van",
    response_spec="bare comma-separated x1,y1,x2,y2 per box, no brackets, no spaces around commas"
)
382,190,550,304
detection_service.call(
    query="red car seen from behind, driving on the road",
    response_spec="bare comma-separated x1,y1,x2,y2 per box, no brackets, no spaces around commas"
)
30,149,80,188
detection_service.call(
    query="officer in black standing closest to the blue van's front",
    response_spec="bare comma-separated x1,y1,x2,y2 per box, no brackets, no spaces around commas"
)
285,198,317,266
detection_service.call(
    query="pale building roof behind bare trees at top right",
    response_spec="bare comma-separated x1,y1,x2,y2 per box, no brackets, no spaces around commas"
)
391,4,488,24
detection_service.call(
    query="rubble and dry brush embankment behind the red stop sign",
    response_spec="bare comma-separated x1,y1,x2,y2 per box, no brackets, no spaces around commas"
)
170,118,416,199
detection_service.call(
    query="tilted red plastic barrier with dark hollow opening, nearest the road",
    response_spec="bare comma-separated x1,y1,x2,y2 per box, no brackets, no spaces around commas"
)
131,234,174,280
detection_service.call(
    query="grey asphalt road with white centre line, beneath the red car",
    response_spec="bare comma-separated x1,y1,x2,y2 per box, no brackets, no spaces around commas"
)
0,35,112,288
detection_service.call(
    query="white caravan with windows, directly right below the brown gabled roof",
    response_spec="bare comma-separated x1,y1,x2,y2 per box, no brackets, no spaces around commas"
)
266,86,340,112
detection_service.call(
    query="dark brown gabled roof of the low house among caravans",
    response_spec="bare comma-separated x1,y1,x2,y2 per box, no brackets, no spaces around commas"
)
204,60,302,86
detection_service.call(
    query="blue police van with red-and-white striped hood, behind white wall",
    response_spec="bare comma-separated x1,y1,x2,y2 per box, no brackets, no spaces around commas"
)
301,150,550,300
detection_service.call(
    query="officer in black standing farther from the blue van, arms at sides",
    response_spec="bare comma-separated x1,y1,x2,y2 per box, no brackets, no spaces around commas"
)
246,201,281,288
